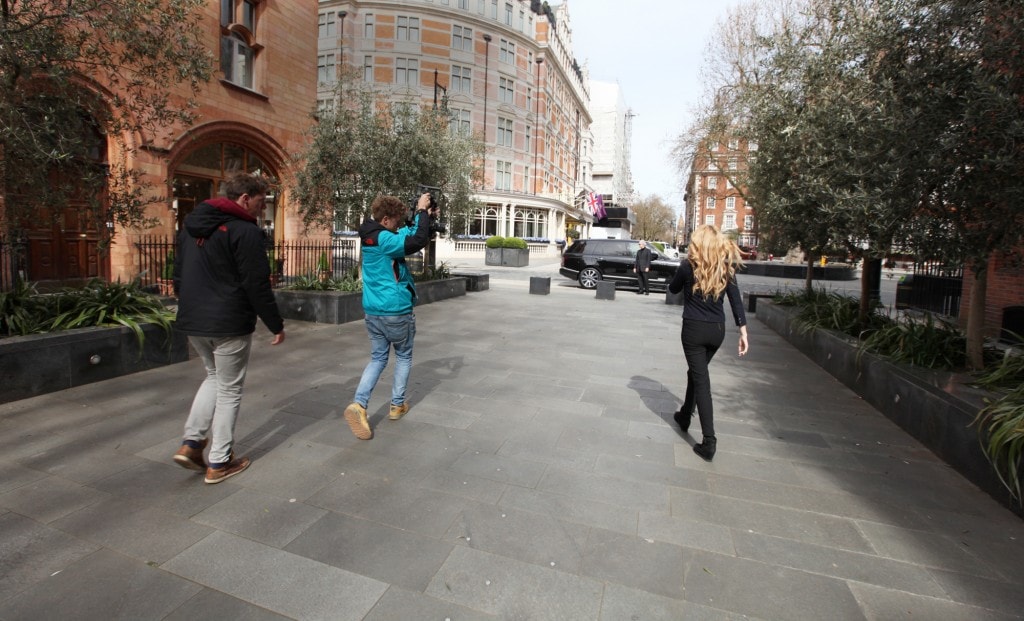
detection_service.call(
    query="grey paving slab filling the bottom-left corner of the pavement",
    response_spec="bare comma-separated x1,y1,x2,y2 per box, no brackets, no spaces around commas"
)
3,549,200,621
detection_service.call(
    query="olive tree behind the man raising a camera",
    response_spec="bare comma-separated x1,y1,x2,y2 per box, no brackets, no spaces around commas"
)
293,74,483,235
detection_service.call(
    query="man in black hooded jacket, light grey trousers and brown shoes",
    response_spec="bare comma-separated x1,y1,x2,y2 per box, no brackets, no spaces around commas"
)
174,173,285,484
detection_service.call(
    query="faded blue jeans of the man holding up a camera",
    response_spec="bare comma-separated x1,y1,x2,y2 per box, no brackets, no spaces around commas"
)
355,313,416,408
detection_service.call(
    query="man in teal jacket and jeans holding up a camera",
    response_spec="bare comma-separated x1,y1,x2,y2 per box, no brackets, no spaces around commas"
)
345,194,432,440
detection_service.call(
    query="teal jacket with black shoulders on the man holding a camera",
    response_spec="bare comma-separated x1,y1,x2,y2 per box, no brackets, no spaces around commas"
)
359,212,430,315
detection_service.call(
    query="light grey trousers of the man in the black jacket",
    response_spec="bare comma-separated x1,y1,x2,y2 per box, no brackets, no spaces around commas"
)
184,334,253,463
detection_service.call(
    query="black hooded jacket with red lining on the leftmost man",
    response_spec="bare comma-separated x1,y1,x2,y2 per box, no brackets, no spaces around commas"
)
174,198,285,337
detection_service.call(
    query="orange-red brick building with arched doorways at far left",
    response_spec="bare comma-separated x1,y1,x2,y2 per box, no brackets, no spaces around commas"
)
9,0,316,283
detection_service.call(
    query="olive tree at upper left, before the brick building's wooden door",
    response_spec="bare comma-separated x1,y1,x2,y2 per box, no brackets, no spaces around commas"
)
0,0,213,241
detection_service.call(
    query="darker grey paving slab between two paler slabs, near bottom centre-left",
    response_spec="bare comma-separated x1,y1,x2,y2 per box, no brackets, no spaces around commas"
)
285,512,453,592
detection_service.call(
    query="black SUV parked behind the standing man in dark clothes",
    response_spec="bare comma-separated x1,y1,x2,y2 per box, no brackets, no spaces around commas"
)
558,240,679,289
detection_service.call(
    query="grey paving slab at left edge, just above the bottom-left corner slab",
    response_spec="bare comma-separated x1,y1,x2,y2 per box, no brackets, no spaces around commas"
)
0,512,99,606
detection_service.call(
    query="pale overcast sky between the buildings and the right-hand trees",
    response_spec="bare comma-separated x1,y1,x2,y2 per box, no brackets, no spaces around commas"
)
569,0,739,212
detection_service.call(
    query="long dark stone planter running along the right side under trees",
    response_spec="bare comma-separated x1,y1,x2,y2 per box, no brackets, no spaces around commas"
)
757,299,1024,516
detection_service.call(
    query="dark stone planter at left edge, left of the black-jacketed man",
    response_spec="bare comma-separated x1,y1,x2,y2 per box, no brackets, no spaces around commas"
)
0,324,188,403
